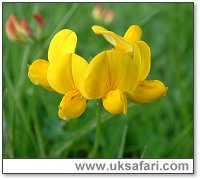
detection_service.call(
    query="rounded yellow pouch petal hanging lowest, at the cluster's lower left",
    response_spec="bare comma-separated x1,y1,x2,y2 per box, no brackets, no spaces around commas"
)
58,90,86,120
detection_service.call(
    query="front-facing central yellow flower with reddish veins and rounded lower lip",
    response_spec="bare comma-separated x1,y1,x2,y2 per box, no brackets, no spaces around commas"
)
84,47,141,114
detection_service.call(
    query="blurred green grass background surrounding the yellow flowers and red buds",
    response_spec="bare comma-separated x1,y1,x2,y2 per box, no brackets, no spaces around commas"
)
3,3,193,158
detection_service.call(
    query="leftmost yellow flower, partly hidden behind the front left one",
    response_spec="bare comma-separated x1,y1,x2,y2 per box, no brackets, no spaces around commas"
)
28,29,77,90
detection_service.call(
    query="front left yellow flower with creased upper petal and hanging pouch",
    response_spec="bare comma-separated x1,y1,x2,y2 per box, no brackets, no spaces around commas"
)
47,53,88,120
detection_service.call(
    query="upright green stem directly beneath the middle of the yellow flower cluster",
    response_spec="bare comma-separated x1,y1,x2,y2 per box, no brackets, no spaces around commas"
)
89,100,101,158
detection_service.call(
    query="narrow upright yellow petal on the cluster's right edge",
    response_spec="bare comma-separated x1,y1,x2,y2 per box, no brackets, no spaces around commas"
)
136,41,151,81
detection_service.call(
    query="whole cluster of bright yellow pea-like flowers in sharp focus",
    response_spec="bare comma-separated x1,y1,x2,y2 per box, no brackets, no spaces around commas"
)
28,25,167,120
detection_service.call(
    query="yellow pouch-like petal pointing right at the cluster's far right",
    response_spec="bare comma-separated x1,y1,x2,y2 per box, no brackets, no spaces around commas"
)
130,80,168,104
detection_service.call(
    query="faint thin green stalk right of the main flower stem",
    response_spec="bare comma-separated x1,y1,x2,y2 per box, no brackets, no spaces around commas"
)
118,116,128,158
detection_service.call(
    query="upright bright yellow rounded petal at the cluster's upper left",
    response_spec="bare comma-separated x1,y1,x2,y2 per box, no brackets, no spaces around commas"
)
48,29,77,62
